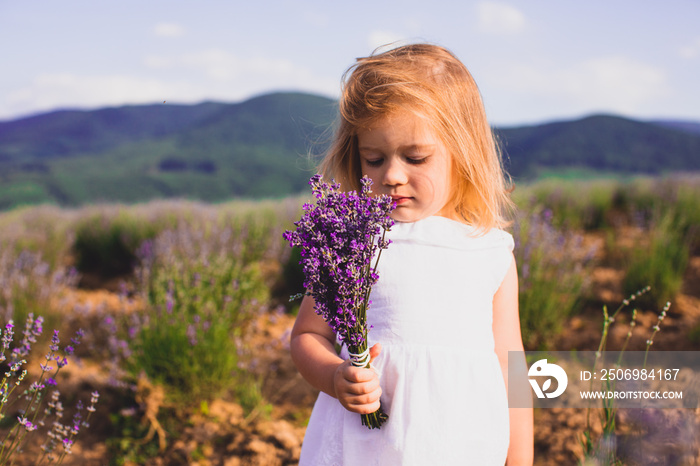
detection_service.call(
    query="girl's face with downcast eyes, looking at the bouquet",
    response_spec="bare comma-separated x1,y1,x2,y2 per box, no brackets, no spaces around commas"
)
357,111,456,222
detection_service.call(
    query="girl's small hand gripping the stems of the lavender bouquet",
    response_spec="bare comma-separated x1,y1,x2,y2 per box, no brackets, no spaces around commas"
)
333,343,382,414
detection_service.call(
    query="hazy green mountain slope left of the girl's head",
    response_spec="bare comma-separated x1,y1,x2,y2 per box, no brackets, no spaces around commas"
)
0,93,335,209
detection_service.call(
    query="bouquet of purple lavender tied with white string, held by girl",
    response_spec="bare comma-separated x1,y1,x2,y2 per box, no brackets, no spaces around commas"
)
283,175,394,429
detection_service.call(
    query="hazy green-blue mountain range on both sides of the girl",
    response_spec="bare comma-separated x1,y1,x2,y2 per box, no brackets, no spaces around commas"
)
0,93,700,209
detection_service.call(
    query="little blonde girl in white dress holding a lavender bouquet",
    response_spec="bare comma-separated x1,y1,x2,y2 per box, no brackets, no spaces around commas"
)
291,44,533,466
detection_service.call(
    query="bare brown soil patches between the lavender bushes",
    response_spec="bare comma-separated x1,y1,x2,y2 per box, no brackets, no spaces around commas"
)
6,246,700,466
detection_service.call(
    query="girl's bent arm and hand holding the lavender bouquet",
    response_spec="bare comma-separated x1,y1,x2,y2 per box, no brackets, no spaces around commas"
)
290,296,382,414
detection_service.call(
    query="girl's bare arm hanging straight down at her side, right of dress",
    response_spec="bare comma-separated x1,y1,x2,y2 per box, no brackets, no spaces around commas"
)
493,258,534,466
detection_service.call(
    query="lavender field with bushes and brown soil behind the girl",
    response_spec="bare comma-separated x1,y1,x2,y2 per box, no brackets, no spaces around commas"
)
0,176,700,465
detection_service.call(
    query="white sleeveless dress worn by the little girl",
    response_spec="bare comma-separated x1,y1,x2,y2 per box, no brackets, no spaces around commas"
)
300,217,513,466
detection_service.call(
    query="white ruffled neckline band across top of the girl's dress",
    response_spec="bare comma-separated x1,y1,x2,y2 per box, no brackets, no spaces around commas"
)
387,216,514,251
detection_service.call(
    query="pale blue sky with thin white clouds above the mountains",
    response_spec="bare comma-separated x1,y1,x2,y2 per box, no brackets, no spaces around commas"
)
0,0,700,125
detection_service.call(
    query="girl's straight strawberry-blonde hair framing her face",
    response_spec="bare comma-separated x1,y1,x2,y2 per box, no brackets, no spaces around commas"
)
320,44,513,230
